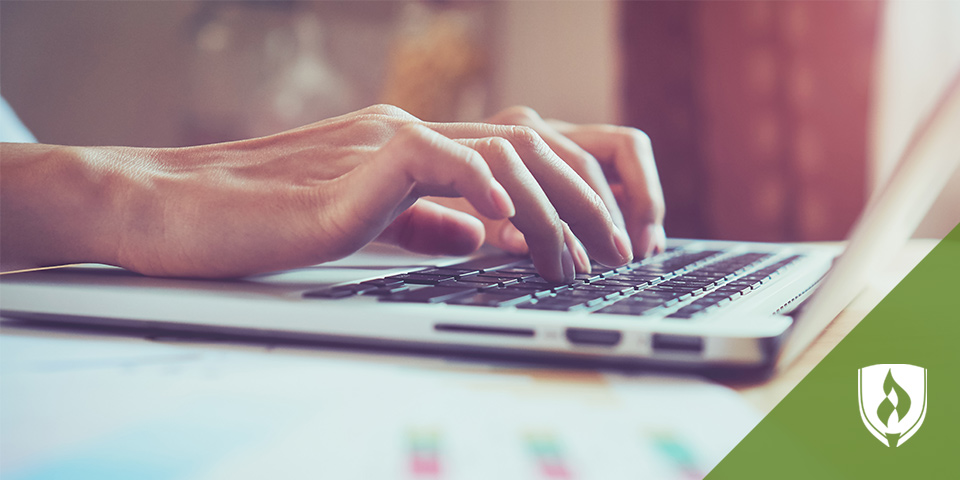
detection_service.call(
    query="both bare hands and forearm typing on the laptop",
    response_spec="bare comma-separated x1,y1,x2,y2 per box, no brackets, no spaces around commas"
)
0,105,665,281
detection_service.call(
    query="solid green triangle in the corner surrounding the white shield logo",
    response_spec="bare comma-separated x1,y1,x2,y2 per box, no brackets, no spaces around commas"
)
706,225,960,480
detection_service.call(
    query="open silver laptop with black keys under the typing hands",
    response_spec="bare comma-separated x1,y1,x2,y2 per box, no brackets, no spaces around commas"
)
0,71,960,371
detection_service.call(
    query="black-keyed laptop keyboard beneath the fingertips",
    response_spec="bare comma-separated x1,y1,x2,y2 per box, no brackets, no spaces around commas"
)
304,249,801,319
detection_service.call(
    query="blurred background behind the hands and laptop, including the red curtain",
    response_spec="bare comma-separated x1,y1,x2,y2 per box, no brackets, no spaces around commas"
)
0,0,960,241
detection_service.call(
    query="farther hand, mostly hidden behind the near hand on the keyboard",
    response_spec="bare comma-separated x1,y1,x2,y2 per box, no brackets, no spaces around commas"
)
442,107,666,257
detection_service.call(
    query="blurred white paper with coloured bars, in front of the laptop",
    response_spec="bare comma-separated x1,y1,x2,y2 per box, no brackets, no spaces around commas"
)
0,334,760,480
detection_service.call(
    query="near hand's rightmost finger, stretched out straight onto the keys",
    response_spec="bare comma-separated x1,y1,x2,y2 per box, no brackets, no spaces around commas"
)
427,123,633,265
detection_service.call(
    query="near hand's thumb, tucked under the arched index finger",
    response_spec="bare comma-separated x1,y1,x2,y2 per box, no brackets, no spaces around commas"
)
377,199,484,255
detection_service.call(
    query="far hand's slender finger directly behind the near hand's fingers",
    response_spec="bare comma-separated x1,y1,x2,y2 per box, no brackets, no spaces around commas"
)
490,107,626,232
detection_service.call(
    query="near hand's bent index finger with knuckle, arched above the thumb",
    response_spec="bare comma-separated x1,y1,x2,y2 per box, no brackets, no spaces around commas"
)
330,125,515,256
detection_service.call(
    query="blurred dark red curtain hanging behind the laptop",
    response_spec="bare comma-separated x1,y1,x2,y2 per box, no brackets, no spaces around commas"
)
621,1,882,241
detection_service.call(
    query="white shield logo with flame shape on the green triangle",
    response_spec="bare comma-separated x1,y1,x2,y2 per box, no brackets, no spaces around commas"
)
857,363,927,447
